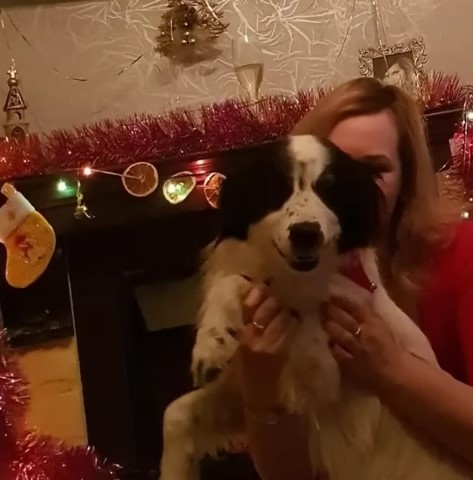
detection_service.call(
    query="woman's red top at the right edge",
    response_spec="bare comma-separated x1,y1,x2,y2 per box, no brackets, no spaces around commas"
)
419,221,473,386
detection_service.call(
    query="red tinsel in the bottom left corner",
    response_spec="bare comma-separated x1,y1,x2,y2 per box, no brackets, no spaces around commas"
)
0,332,118,480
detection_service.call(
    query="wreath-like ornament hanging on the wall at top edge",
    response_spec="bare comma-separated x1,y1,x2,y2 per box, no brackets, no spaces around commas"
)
156,0,228,64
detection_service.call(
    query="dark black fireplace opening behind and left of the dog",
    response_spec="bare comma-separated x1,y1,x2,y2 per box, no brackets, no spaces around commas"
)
58,210,258,480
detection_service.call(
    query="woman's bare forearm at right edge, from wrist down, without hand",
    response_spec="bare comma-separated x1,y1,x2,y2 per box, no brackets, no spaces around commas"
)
381,353,473,462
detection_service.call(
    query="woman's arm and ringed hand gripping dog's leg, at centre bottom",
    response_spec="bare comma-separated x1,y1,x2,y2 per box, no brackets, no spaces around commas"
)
238,286,315,480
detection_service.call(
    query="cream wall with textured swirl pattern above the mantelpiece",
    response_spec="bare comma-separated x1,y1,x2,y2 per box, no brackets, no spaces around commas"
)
0,0,473,130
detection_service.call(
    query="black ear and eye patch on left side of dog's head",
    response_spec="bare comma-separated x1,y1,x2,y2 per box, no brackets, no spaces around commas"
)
219,140,292,240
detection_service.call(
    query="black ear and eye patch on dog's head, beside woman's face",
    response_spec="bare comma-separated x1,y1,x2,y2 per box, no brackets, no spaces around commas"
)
314,144,384,253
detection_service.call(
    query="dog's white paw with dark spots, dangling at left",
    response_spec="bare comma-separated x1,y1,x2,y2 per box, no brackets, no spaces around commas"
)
191,327,238,387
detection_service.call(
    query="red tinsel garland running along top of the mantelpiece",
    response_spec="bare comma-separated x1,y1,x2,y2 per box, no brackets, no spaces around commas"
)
0,72,464,180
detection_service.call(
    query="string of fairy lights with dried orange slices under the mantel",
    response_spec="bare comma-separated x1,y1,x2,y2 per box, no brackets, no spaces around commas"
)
52,162,225,219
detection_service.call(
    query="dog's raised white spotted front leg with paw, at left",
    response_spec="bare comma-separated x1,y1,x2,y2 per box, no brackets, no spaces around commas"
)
192,275,251,386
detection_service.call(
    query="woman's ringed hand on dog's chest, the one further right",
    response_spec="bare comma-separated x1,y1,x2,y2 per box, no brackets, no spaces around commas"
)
322,275,403,389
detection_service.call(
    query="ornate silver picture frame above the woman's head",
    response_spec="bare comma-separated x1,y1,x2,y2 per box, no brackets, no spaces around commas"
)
359,37,427,99
